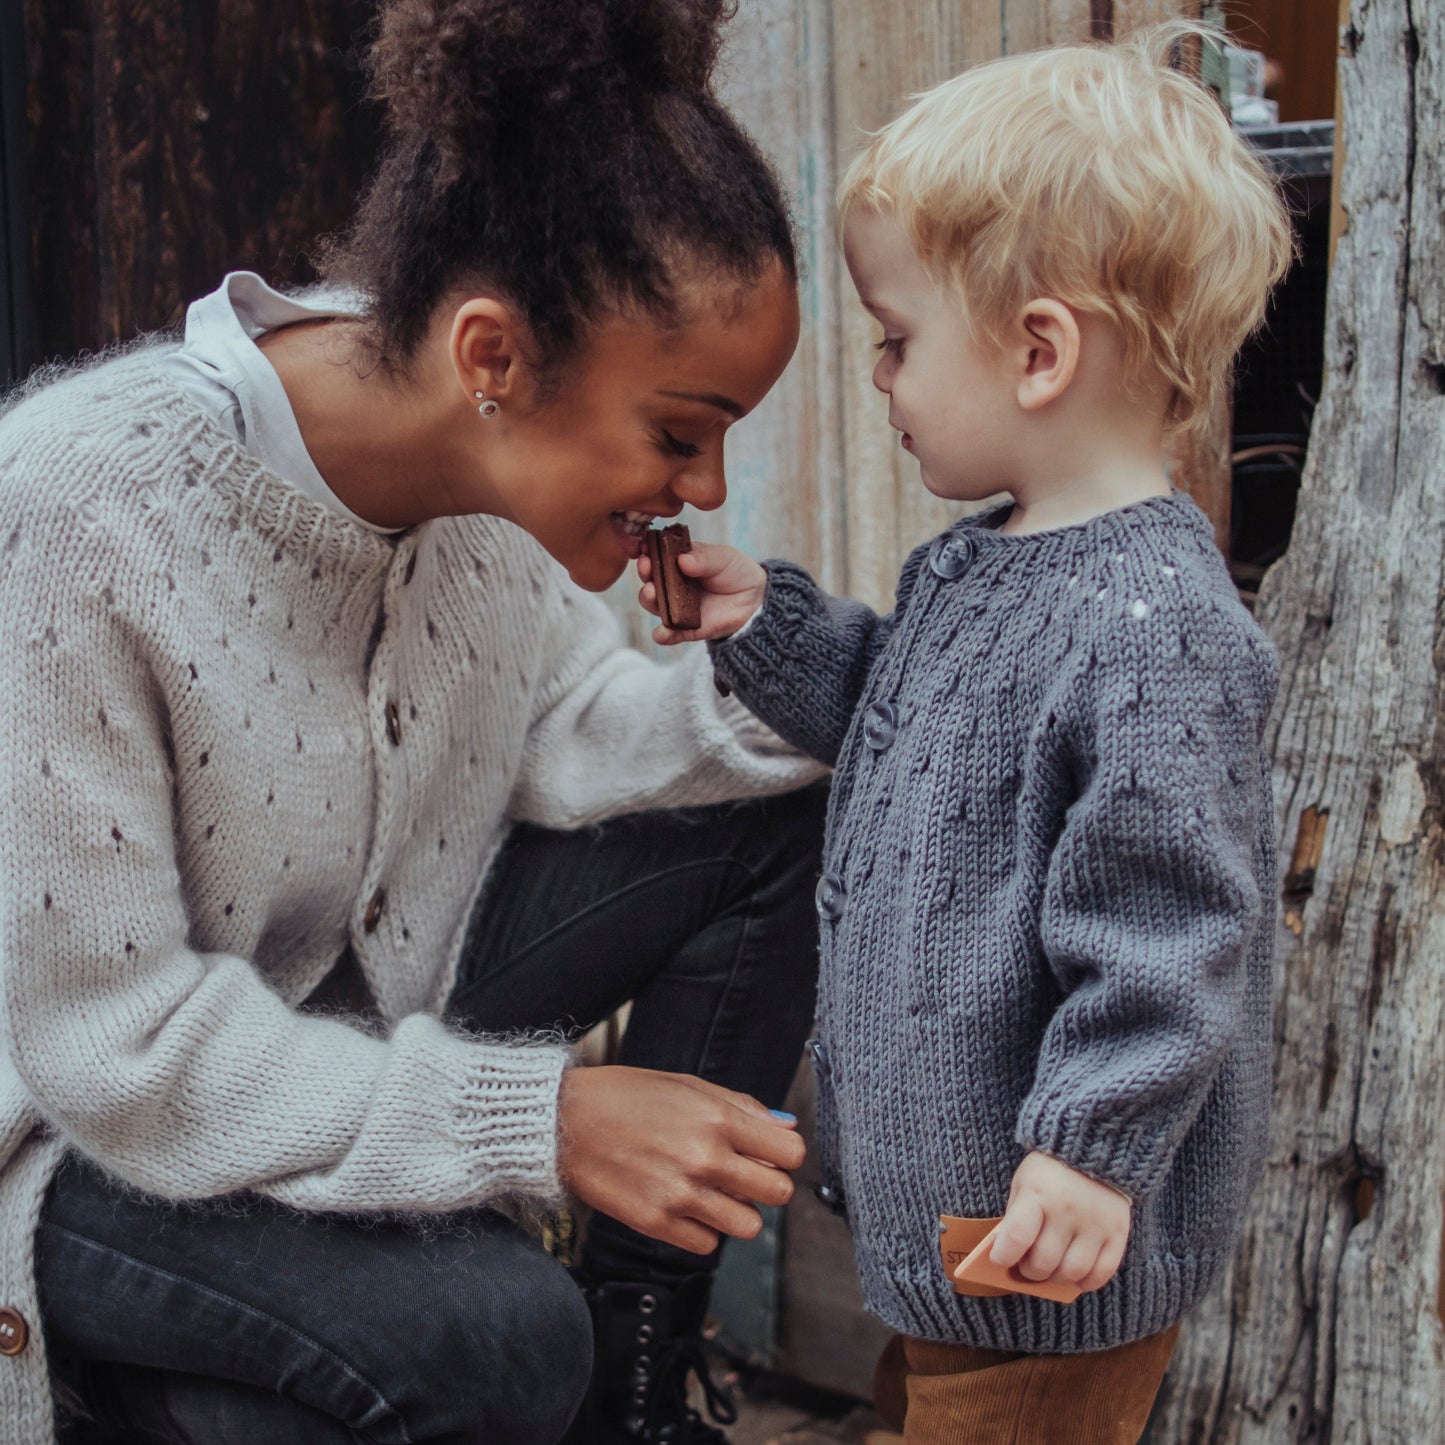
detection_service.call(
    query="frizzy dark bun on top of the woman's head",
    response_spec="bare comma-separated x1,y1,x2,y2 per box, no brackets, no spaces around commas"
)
370,0,734,178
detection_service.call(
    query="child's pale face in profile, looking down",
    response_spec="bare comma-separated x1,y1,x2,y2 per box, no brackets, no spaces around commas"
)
842,211,1023,501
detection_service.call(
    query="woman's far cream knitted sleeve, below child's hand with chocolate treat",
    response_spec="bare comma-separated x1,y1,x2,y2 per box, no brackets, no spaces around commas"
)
509,564,822,828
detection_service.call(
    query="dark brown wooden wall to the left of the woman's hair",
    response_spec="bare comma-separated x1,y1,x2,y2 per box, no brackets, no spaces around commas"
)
25,0,377,357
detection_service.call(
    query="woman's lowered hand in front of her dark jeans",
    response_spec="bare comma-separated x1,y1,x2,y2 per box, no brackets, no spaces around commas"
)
558,1065,805,1254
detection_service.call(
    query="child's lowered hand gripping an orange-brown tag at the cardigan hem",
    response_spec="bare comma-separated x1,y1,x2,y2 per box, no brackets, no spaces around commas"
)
988,1152,1133,1290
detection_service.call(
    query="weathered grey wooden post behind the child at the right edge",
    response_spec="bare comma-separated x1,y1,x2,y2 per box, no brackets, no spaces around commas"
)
1149,0,1445,1445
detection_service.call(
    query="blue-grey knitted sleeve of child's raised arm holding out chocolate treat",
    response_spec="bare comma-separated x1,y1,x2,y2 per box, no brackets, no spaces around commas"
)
708,546,928,767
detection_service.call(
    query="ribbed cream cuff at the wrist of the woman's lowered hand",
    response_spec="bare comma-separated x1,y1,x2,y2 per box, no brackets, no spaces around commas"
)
457,1045,571,1201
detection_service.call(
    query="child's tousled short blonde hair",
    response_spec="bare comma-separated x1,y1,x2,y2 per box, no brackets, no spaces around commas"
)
838,22,1293,431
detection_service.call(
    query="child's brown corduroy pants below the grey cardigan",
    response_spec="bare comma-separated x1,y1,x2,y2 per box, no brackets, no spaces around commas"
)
874,1325,1179,1445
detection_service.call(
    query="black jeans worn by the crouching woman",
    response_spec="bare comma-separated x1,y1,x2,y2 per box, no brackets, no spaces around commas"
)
36,788,822,1445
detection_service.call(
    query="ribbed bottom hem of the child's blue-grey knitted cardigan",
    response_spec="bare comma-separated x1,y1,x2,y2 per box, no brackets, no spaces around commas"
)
860,1253,1231,1354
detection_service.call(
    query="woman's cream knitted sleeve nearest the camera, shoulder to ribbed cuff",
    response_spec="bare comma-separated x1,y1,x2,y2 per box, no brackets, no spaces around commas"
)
0,503,566,1211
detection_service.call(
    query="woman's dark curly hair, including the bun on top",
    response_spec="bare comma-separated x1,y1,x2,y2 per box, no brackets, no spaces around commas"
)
322,0,796,371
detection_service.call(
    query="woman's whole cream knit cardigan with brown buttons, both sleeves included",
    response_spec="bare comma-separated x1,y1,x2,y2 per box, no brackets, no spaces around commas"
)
0,348,818,1445
